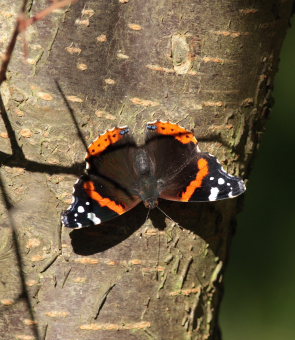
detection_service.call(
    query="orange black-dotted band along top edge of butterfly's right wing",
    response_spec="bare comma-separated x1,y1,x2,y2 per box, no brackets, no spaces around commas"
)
152,121,198,144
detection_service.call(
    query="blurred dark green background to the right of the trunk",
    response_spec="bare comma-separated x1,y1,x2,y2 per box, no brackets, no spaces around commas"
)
220,18,295,340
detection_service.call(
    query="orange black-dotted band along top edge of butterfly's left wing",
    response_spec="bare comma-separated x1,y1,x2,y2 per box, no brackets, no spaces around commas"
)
86,128,127,158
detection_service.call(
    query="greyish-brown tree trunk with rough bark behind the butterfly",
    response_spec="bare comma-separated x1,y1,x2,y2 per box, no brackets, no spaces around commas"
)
0,0,292,340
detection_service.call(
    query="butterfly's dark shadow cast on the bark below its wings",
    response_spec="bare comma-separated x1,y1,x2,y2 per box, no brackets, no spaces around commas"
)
70,200,236,256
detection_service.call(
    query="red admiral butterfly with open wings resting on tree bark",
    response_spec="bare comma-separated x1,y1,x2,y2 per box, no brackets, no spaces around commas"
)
62,121,246,228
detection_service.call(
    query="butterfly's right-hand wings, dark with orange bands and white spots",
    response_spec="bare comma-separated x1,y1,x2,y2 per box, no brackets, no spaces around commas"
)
146,121,245,202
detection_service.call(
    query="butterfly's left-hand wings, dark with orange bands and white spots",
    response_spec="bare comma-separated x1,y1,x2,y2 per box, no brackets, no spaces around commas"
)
62,127,141,228
